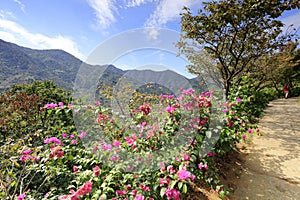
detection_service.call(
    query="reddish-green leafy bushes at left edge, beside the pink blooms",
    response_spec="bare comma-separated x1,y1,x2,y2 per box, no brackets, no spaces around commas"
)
0,81,75,198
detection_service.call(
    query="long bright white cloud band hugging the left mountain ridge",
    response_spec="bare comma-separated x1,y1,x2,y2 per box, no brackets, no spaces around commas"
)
0,19,84,59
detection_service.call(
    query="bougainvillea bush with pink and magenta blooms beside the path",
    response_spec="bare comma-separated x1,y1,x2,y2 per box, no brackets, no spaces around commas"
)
0,80,268,199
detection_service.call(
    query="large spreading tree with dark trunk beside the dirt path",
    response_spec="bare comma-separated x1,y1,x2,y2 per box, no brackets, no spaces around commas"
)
178,0,300,97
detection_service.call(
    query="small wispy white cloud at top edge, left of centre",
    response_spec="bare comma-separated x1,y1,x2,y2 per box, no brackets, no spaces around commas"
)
87,0,117,29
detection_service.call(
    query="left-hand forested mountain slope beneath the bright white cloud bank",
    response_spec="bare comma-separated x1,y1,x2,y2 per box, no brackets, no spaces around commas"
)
0,40,82,89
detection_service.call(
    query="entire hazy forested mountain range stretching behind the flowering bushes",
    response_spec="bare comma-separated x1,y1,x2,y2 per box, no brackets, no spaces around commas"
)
0,39,204,93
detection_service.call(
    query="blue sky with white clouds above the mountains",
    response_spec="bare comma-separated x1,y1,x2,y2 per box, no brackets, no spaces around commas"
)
0,0,300,77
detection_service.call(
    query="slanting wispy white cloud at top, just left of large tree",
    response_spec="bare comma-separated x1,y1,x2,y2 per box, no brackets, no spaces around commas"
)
145,0,199,27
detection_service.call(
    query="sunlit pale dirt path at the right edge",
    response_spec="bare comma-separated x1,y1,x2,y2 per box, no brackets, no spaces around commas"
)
230,98,300,200
